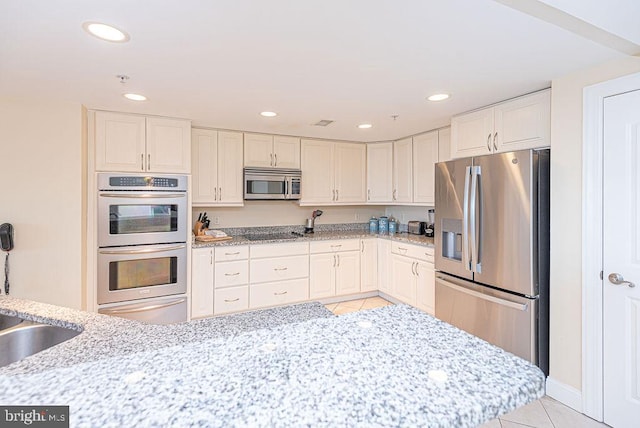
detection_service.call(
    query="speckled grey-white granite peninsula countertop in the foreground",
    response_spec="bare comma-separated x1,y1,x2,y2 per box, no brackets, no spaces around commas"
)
0,298,545,427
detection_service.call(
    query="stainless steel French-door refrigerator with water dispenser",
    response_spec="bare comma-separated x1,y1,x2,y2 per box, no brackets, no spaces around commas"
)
435,149,550,374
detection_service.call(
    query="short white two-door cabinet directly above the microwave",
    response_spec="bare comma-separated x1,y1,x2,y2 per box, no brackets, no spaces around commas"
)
244,133,300,169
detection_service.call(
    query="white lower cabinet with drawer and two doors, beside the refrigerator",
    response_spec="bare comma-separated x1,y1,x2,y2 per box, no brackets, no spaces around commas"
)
389,242,435,315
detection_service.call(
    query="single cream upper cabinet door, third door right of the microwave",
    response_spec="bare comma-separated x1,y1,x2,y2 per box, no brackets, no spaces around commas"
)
367,143,393,202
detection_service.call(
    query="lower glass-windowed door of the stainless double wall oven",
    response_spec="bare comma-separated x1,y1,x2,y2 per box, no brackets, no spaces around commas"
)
98,244,187,304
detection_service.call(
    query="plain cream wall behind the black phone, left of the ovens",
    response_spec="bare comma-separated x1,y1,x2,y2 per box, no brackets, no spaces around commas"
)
0,98,85,308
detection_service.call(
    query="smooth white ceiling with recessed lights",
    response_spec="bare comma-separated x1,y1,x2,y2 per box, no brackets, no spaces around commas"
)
0,0,635,141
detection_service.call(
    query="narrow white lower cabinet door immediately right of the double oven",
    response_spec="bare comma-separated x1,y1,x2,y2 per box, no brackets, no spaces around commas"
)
191,248,213,318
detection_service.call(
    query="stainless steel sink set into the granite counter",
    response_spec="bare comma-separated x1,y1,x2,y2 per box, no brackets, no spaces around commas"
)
0,315,80,367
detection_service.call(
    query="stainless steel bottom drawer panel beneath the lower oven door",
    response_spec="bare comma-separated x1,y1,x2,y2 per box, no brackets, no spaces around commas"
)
98,295,188,324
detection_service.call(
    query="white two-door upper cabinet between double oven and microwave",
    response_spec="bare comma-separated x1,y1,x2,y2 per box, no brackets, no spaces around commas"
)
191,128,244,206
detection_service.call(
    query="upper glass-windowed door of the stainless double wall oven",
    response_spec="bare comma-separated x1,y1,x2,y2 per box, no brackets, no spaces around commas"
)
98,191,188,247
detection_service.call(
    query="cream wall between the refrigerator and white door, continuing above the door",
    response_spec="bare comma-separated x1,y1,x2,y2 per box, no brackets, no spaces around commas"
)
549,57,640,390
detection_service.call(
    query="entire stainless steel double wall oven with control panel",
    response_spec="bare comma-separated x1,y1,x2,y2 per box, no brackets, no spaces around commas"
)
97,173,189,324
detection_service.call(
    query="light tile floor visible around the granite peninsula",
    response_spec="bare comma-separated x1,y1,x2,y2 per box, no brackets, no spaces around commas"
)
325,297,608,428
